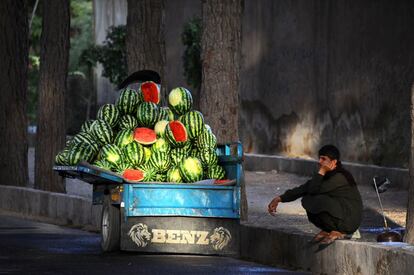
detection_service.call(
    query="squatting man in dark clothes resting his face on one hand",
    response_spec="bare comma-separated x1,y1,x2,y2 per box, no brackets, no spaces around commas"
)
268,145,362,245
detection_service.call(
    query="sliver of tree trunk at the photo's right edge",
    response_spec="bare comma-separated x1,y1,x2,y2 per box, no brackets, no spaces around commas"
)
404,84,414,244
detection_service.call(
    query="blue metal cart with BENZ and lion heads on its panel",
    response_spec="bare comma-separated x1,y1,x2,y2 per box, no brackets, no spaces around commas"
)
54,142,243,256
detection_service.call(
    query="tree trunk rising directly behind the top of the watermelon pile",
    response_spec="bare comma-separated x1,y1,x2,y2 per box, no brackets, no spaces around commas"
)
126,0,166,98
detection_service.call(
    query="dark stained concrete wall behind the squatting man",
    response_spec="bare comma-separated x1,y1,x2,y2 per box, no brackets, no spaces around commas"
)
240,0,414,166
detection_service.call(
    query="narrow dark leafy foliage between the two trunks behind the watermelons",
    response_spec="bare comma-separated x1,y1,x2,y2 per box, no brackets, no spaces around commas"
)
181,17,202,89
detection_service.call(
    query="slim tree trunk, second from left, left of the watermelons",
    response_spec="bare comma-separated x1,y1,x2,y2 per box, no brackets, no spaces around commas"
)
35,0,70,192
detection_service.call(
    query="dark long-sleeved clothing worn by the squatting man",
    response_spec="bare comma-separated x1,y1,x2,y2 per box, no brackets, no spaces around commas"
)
280,167,362,234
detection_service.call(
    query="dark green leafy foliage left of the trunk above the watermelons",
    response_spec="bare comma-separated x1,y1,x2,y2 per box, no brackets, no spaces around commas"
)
81,25,127,85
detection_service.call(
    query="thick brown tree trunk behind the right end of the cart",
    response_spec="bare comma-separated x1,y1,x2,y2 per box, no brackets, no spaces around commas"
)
200,0,247,220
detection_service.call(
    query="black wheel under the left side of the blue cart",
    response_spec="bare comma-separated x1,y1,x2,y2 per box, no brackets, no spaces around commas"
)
101,198,121,252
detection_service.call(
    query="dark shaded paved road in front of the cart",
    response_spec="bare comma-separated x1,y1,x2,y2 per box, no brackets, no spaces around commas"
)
0,216,304,275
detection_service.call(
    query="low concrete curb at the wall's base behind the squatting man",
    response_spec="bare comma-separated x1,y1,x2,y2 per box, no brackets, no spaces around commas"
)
243,154,410,190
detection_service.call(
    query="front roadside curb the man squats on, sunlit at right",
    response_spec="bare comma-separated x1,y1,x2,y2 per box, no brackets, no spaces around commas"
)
240,226,414,274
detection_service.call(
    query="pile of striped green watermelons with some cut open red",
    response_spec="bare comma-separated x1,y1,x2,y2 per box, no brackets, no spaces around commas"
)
55,81,225,183
